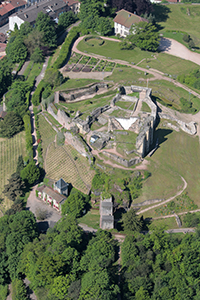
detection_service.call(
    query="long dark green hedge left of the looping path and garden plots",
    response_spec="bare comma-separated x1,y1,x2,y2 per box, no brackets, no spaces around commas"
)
53,27,80,69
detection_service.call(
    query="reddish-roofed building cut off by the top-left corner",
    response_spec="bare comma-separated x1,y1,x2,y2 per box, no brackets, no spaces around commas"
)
0,0,26,26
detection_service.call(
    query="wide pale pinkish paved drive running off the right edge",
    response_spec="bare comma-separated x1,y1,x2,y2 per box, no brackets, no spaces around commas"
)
159,38,200,65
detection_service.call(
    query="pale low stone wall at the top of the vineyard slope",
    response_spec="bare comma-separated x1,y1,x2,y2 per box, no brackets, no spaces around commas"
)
64,132,93,164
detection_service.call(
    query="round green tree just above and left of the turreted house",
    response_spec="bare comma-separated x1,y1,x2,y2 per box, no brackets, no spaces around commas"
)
20,160,40,185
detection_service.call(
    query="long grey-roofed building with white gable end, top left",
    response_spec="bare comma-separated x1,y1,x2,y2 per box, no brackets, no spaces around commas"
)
9,0,69,30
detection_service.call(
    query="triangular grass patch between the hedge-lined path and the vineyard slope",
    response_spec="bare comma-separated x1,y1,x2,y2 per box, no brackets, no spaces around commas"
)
39,115,56,160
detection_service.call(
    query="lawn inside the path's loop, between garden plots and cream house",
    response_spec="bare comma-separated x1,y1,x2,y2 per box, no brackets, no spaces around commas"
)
78,39,152,63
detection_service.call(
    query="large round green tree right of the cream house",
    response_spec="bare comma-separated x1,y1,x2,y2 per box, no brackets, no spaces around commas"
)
128,22,160,52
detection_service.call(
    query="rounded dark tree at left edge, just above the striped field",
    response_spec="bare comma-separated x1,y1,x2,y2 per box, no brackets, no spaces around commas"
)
0,111,23,138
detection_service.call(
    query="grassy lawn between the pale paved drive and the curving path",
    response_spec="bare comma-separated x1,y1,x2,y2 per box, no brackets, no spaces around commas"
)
139,53,199,76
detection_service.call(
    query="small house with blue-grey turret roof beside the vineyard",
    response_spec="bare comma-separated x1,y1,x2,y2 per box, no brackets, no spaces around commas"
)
36,178,69,211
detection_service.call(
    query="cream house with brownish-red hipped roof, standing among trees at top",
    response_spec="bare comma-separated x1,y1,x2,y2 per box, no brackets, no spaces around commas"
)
113,9,148,37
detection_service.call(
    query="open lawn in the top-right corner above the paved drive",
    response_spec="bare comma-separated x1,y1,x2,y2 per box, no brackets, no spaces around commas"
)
158,4,200,47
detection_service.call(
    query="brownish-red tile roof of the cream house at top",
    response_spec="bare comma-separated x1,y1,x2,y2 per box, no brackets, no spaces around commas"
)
113,9,148,28
